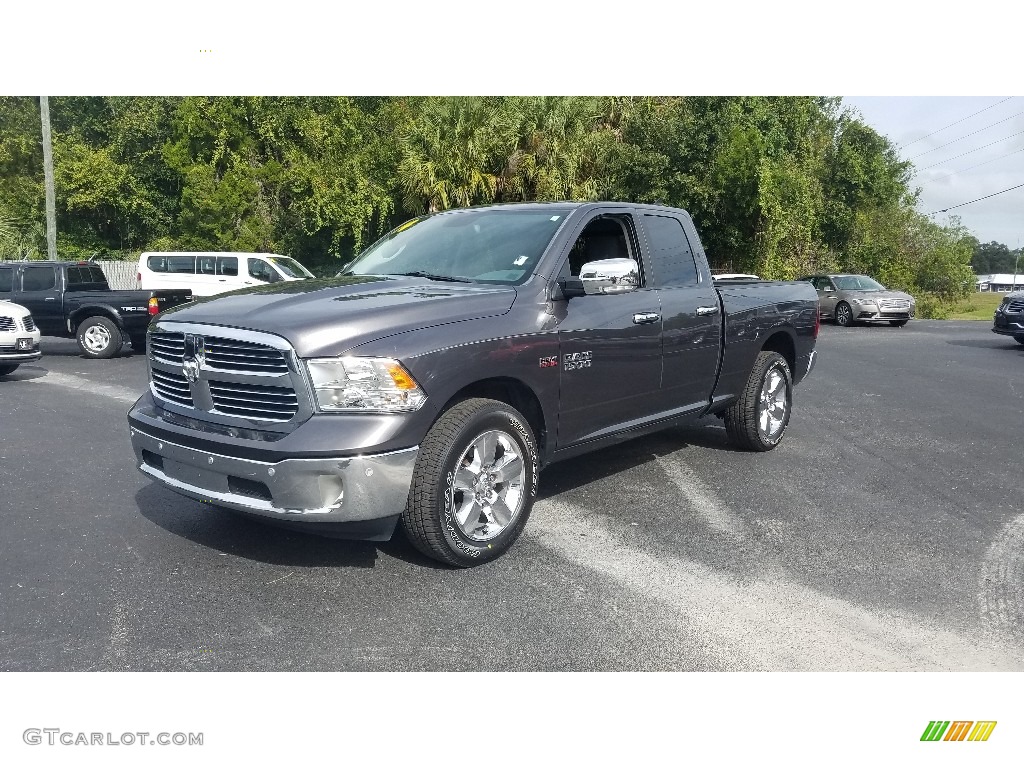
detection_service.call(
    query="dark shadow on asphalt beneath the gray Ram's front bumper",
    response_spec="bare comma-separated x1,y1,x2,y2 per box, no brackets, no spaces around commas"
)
135,485,449,570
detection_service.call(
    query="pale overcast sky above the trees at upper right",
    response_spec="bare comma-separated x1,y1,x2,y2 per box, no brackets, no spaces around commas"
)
844,96,1024,249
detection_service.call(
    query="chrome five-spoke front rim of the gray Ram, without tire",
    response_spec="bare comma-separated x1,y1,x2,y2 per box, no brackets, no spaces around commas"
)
452,429,526,542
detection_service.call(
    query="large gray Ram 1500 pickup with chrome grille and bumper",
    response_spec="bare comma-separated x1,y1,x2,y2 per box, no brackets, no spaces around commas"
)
128,203,818,566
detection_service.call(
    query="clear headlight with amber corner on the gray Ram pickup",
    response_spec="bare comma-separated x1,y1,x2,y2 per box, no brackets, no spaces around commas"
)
306,357,427,413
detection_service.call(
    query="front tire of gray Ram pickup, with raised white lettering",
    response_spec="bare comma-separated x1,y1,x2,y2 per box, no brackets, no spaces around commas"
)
401,397,539,567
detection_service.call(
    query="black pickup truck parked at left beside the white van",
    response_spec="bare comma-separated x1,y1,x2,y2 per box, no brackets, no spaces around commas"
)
0,261,191,357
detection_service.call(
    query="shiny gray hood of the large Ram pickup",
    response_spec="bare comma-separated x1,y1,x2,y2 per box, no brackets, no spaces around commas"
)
154,275,516,357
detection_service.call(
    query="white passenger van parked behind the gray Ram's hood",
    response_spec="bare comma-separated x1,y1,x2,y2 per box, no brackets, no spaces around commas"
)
136,251,313,296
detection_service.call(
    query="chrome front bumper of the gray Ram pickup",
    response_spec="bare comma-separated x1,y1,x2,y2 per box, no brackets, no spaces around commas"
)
131,427,419,523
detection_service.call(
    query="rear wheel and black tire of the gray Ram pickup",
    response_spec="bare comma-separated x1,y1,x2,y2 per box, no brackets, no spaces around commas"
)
725,352,793,451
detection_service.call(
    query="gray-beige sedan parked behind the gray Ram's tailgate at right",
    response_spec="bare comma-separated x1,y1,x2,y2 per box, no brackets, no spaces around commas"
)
800,274,916,327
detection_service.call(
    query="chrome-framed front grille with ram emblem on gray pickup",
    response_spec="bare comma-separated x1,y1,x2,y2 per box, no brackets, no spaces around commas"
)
146,321,312,431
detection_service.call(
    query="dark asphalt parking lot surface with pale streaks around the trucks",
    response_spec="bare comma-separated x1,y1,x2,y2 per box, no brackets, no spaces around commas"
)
0,321,1024,671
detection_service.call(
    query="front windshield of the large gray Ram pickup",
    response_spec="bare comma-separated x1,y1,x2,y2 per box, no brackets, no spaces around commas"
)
344,208,569,284
